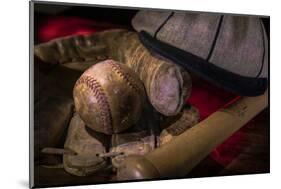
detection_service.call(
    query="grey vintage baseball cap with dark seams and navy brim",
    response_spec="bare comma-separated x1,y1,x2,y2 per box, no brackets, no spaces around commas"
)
132,10,268,96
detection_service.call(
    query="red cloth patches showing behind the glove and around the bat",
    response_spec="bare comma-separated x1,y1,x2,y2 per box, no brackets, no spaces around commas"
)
38,16,245,166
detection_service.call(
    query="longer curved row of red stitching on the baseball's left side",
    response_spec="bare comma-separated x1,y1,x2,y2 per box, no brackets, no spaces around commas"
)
75,76,113,133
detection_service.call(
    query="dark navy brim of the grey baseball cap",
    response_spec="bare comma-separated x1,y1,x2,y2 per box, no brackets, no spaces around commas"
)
139,31,267,96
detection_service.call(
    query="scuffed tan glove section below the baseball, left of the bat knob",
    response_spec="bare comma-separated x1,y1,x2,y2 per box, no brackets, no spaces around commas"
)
63,114,108,176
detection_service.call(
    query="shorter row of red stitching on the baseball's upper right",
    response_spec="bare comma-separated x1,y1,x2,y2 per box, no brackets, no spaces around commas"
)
108,61,142,94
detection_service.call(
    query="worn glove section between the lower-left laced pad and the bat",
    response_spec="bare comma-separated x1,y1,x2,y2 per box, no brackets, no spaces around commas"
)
110,102,160,168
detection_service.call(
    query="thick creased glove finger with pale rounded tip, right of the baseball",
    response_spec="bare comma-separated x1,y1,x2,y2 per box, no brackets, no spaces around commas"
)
125,34,192,116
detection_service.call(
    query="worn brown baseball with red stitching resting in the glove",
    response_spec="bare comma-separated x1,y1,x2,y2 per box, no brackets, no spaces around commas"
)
73,60,145,134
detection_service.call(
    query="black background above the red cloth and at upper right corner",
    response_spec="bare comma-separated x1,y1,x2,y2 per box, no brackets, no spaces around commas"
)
34,3,270,44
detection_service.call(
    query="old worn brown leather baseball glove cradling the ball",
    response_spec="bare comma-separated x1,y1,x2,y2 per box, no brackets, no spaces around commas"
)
35,30,199,176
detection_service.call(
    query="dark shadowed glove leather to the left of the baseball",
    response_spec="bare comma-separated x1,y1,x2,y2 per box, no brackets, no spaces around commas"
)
33,59,79,162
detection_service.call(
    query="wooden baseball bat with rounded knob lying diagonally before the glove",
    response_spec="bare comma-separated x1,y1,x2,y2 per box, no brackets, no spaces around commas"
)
117,91,268,180
